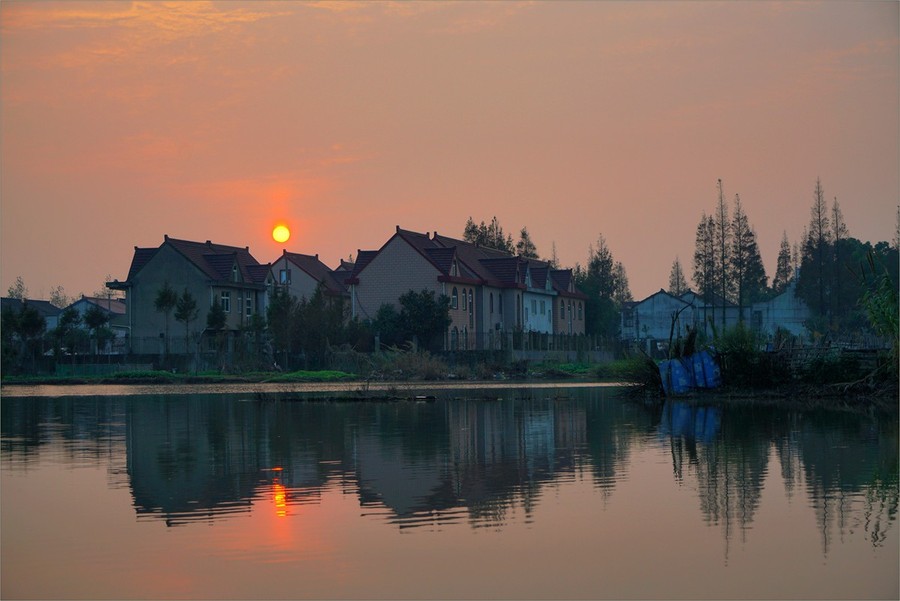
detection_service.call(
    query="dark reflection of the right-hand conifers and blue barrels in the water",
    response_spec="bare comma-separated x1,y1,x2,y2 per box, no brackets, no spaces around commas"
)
660,403,898,556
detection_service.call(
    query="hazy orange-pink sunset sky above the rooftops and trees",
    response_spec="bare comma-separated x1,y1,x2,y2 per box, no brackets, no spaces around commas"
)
0,0,900,299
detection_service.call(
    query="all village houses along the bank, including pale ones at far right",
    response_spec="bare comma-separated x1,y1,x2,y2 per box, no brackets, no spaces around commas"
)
3,226,810,354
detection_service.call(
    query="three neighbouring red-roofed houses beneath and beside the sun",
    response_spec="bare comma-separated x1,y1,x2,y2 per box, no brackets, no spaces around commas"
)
107,226,586,353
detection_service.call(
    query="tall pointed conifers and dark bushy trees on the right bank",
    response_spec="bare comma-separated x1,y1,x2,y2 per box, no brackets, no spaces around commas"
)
669,178,900,335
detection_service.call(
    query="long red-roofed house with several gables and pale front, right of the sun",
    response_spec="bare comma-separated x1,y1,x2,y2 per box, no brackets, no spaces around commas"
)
345,226,585,350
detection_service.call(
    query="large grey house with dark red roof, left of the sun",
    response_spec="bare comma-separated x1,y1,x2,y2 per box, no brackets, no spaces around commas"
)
107,235,275,354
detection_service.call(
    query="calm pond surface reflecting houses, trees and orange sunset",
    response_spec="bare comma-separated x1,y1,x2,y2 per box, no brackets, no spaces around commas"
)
0,385,900,599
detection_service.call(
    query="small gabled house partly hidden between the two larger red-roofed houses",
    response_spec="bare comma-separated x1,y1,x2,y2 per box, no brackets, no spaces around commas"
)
272,250,353,312
